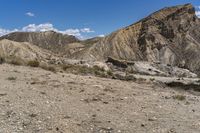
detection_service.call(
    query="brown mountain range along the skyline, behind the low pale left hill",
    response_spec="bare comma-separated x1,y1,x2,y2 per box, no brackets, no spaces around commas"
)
0,4,200,74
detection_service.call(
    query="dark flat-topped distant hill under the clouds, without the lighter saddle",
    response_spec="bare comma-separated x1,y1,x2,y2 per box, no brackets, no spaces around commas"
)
0,31,79,53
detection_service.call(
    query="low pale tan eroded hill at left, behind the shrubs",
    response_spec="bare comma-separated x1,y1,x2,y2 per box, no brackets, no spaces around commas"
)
0,39,59,64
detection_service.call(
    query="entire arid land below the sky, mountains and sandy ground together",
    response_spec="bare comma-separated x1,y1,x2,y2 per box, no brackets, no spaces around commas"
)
0,4,200,133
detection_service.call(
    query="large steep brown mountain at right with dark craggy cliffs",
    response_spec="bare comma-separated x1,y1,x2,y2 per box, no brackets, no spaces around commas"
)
73,4,200,75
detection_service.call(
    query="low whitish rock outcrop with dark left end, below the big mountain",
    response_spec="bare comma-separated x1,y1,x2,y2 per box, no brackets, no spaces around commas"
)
106,57,197,78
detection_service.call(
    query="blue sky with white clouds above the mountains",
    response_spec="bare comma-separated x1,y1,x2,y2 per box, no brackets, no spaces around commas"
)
0,0,200,38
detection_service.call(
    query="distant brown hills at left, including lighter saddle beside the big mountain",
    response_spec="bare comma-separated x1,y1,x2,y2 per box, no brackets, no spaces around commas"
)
0,31,101,58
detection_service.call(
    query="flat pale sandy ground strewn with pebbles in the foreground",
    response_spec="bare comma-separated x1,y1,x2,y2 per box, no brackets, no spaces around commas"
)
0,64,200,133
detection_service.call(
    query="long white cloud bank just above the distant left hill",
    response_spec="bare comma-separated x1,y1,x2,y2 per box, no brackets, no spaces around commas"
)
0,23,95,39
